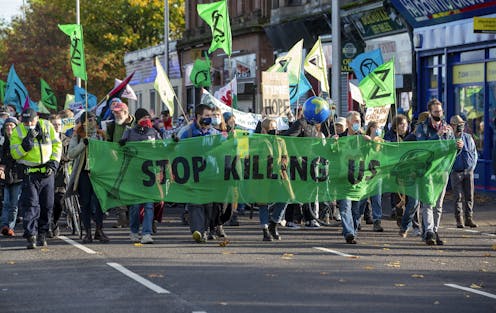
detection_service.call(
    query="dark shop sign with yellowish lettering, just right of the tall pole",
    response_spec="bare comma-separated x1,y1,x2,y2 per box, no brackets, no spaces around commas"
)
351,7,405,38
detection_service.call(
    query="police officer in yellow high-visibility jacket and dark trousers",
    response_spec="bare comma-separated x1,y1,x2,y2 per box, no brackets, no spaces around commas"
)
10,108,62,249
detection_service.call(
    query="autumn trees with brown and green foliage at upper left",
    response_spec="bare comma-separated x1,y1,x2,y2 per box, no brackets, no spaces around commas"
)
0,0,184,109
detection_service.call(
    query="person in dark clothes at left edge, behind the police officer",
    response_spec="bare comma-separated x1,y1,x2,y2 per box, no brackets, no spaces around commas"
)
0,117,22,237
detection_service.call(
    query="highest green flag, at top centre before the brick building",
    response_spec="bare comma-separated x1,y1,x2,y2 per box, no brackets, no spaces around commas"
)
196,0,232,56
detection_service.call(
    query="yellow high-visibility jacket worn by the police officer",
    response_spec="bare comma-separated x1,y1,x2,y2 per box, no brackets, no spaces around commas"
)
10,119,62,167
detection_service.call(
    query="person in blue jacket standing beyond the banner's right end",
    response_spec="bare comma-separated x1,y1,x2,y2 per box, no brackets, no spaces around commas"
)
450,115,478,228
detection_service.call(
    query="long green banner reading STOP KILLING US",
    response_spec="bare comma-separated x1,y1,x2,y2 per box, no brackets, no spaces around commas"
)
89,132,456,209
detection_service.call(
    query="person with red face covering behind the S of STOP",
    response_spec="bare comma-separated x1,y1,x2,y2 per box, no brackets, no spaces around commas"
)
119,108,160,244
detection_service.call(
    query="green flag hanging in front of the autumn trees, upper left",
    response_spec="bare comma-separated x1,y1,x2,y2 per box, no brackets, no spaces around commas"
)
59,24,88,80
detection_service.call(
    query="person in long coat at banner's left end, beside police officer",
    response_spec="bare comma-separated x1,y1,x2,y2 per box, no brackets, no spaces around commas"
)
67,112,109,243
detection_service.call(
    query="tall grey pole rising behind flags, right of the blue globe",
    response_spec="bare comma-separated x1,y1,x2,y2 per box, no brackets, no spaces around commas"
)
331,0,342,114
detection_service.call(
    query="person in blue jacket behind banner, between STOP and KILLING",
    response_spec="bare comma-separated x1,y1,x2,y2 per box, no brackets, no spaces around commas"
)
175,104,219,243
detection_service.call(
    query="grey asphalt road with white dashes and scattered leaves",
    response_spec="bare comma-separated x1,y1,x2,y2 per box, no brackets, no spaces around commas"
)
0,195,496,313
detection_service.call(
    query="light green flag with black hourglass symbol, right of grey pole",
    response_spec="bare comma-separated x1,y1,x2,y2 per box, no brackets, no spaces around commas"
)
359,58,396,108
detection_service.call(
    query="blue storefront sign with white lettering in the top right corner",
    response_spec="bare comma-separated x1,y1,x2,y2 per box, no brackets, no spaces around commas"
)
391,0,496,28
